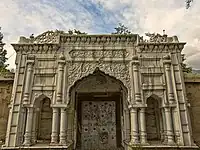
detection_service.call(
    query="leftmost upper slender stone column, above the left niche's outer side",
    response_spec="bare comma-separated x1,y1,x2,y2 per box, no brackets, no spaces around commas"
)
23,56,35,104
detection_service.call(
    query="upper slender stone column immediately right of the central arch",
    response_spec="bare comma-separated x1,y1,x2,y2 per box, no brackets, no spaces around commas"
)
132,56,141,103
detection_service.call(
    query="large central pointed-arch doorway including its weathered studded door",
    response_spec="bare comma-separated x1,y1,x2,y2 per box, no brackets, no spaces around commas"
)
70,70,129,150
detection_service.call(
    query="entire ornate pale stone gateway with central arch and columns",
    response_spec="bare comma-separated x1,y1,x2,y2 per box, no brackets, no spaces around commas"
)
2,31,197,150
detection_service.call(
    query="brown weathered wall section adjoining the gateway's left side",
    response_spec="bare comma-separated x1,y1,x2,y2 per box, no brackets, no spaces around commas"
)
0,74,14,145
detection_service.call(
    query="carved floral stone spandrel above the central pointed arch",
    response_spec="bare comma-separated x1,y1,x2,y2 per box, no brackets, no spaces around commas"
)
67,62,130,103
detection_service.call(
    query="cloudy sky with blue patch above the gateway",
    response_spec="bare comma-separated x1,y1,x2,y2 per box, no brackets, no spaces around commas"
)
0,0,200,69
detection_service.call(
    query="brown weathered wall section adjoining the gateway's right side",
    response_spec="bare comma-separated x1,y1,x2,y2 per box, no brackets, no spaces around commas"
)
185,75,200,145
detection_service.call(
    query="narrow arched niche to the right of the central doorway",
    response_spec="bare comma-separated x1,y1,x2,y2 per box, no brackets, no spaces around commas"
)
146,96,162,142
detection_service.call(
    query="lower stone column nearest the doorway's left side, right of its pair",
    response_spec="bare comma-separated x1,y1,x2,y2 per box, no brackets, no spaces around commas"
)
60,108,67,145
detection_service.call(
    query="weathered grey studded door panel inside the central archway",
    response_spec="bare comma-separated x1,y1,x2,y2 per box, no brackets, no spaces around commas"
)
81,101,117,150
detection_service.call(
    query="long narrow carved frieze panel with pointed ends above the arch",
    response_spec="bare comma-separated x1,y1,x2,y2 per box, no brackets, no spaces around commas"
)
69,49,129,58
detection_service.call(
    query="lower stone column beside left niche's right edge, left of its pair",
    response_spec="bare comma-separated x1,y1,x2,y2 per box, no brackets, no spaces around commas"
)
51,108,59,144
